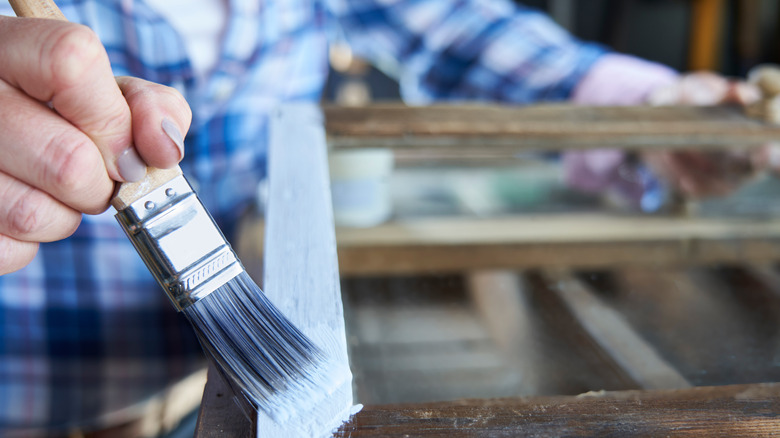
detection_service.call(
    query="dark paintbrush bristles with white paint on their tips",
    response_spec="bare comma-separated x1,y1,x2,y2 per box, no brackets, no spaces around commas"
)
184,272,334,421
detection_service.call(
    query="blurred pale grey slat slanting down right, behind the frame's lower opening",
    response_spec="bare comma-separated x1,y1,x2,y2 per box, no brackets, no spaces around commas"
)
543,271,691,389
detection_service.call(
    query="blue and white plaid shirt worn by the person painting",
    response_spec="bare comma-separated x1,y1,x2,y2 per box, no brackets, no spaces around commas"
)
0,0,602,435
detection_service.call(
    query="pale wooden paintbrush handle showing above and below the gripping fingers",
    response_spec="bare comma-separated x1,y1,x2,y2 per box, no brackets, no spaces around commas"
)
9,0,181,210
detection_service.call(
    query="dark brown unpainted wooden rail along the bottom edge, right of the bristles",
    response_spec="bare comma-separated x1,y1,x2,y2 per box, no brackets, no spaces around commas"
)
336,383,780,438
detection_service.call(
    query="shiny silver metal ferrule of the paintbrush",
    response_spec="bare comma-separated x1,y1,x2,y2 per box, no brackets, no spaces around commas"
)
116,176,244,311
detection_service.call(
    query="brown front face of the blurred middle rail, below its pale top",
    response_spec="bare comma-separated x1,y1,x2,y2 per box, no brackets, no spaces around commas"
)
339,238,780,276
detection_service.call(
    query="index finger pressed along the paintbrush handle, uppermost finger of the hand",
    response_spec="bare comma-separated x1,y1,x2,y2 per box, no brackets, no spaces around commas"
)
0,17,145,181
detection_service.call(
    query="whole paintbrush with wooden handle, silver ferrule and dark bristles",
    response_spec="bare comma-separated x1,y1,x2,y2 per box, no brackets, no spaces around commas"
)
10,0,348,421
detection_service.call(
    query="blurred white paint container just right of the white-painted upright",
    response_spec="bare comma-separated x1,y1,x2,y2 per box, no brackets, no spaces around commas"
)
328,148,394,227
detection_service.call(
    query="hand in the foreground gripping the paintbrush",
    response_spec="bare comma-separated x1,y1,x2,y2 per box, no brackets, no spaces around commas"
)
0,2,191,274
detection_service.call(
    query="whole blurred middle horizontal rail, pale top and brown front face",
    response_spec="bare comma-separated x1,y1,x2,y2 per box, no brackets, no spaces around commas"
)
337,214,780,275
